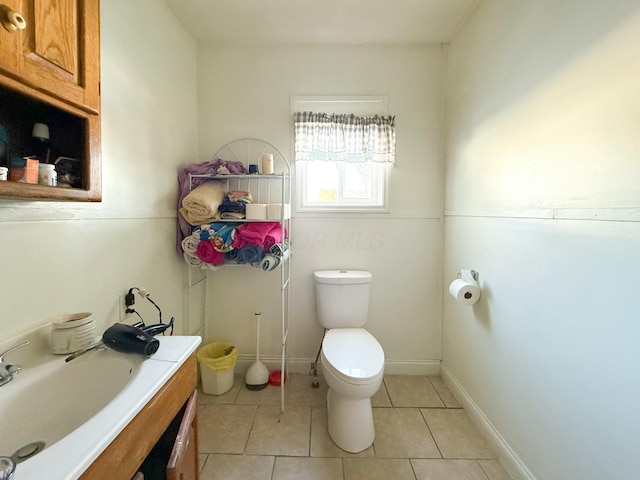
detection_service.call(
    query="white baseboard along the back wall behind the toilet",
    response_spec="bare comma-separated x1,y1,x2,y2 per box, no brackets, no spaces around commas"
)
236,354,440,375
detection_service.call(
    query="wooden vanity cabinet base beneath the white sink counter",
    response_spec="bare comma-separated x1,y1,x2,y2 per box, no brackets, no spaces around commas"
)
80,354,198,480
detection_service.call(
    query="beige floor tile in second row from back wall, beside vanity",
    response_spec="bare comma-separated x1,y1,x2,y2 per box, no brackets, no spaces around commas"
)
198,405,258,453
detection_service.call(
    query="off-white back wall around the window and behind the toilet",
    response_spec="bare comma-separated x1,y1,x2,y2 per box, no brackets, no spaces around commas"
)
198,45,443,373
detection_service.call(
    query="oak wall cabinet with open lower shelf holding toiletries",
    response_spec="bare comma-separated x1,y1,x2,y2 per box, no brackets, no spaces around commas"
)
0,0,101,201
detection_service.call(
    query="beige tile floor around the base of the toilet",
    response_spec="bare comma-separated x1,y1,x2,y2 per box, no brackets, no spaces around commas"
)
198,374,511,480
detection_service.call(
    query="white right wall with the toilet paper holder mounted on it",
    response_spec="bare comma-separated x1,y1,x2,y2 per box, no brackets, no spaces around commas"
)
443,0,640,480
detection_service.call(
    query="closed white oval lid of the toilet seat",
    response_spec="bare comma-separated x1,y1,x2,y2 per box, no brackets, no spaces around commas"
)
322,328,384,380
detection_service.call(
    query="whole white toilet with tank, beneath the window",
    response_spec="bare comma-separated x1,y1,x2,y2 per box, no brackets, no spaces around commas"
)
313,270,384,453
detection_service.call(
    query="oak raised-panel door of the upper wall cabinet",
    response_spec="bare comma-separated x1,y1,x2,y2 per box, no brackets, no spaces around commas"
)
21,0,100,113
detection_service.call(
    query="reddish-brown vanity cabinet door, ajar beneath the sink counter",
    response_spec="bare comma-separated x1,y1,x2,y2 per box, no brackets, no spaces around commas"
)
167,391,199,480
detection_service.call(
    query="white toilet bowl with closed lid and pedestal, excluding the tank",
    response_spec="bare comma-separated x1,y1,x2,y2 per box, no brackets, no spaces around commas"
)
321,328,384,453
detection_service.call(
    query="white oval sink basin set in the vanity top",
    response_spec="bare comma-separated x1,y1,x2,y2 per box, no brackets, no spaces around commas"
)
0,350,144,461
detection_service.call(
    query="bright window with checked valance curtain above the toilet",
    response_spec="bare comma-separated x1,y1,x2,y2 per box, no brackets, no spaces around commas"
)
291,97,395,213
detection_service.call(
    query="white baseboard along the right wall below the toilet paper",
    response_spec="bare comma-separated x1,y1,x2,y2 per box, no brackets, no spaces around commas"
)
440,363,536,480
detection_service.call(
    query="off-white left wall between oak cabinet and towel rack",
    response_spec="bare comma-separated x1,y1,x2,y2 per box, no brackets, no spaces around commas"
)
0,0,197,339
